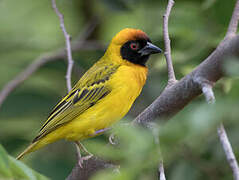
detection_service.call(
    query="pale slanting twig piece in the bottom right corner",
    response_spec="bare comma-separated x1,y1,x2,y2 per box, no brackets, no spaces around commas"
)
217,124,239,180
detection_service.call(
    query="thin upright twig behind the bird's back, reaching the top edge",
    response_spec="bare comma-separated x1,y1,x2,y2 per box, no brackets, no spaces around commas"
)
51,0,74,92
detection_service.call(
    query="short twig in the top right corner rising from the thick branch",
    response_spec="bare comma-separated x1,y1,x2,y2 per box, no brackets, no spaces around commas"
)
226,0,239,37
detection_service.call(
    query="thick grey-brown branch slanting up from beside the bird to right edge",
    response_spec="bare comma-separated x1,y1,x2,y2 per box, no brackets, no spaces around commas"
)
133,35,239,126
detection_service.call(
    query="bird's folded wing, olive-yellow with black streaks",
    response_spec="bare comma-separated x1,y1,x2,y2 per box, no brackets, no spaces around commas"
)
33,64,118,142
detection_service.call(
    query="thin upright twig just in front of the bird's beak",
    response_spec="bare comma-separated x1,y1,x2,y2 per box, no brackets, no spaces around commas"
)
163,0,177,86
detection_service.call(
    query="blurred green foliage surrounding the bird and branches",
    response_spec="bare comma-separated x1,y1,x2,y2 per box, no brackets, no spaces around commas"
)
0,0,239,180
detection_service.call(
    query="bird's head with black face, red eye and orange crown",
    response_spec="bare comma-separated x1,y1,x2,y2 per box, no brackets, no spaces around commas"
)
107,28,162,66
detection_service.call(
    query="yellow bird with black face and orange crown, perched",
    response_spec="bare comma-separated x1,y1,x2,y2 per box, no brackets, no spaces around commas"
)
17,28,162,167
